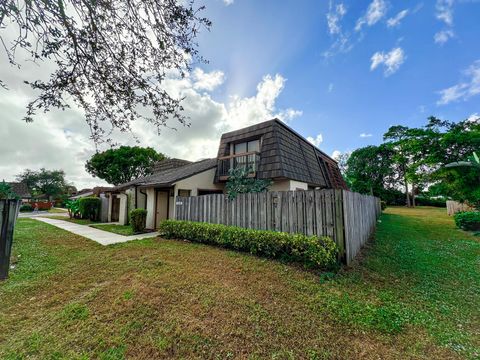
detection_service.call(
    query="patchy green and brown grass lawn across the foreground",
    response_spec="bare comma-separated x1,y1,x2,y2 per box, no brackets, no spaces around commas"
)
0,208,480,359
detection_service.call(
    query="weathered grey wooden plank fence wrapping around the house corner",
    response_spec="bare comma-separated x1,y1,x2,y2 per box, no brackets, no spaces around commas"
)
175,190,381,264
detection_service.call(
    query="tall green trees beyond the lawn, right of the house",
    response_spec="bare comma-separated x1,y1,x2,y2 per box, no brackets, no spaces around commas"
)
339,116,480,207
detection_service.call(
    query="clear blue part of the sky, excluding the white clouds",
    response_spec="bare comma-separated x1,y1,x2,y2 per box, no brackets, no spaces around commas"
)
195,0,480,153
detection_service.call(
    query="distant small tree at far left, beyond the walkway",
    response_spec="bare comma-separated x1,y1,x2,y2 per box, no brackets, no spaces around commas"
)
17,168,72,200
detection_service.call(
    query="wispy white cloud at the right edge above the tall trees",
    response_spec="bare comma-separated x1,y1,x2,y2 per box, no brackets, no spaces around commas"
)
437,60,480,105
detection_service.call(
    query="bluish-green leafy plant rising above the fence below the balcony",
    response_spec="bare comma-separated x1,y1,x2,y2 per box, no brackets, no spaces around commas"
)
226,167,272,200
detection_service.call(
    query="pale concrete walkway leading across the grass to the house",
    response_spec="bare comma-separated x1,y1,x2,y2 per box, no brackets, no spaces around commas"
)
35,217,158,245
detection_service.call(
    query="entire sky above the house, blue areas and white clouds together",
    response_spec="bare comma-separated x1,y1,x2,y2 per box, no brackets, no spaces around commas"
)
0,0,480,188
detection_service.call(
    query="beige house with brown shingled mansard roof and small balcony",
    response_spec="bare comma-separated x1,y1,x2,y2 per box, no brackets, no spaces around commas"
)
108,119,347,229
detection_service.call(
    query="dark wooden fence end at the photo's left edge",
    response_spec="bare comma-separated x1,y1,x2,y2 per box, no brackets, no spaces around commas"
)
0,200,20,280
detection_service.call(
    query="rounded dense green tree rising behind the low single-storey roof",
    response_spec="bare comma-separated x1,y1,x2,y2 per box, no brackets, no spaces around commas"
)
85,146,165,185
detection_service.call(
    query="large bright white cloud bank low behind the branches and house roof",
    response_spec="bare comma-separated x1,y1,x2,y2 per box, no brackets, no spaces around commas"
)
0,52,302,188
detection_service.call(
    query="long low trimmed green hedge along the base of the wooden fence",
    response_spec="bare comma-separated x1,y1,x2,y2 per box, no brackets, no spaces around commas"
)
159,220,337,269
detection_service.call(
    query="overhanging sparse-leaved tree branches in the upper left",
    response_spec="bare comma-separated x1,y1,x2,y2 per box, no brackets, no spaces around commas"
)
0,0,211,142
